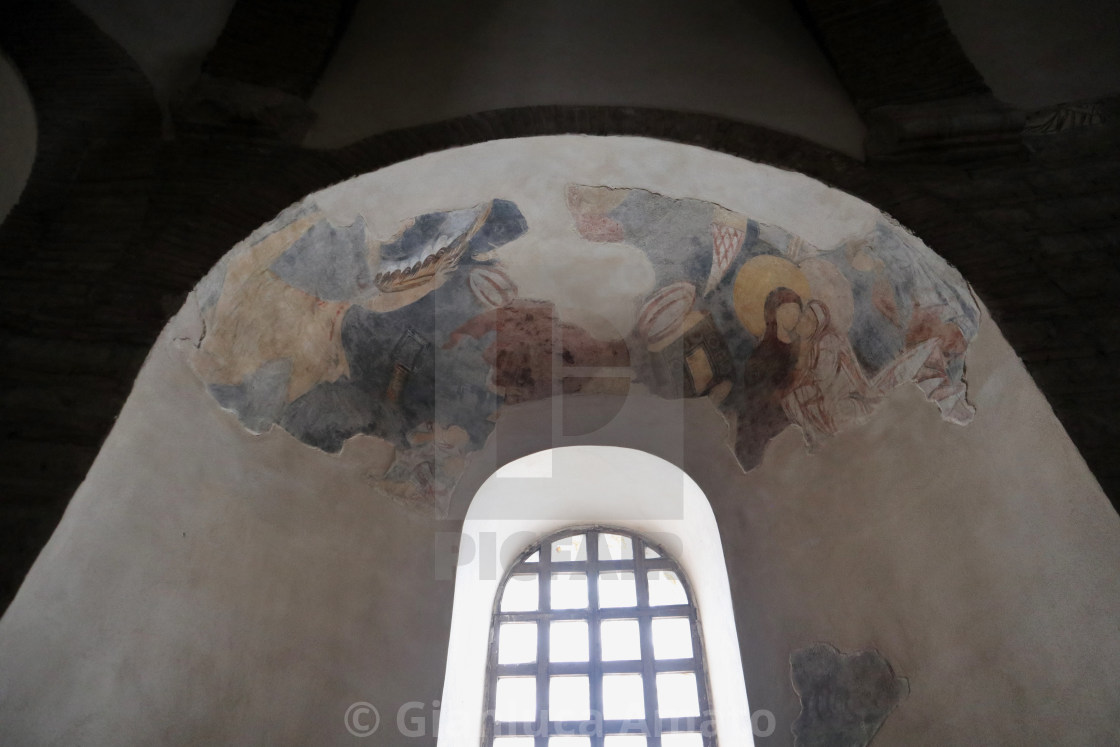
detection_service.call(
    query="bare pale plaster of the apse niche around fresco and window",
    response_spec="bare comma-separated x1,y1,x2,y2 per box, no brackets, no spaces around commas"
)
0,138,1120,746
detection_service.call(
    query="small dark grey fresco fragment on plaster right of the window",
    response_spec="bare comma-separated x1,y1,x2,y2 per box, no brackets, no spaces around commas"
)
790,643,909,747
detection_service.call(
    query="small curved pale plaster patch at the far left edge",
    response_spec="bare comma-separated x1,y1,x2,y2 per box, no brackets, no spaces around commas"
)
0,52,38,223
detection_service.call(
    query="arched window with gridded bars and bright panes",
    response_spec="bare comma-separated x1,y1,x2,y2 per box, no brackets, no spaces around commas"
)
483,527,716,747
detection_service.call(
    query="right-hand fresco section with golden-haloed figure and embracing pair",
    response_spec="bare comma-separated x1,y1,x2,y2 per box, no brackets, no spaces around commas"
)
568,186,979,469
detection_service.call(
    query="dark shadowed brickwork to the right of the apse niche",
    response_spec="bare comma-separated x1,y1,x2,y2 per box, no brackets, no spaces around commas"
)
795,0,1120,517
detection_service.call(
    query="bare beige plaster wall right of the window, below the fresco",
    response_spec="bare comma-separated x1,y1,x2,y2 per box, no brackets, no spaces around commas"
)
725,309,1120,746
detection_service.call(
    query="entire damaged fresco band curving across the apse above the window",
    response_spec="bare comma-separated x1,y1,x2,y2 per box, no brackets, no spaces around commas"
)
192,185,980,510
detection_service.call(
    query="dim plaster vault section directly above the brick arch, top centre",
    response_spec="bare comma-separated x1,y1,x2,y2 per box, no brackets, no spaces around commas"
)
307,0,864,157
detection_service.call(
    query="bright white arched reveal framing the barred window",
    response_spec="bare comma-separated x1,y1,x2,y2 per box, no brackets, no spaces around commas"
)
439,446,754,747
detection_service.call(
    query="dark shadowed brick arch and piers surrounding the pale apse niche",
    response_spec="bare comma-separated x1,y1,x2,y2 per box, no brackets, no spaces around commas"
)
0,0,1120,607
